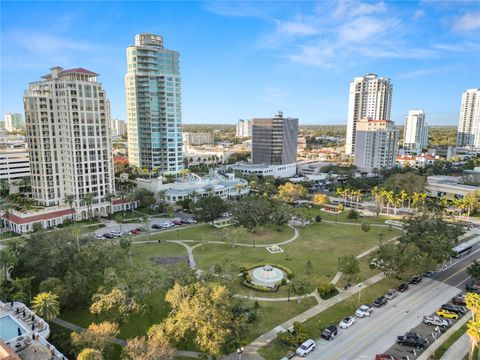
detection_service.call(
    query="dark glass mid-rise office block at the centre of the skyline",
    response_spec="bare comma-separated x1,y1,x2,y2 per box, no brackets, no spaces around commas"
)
252,111,298,165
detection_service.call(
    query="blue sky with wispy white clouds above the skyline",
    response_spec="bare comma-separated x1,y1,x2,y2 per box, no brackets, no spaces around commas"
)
0,0,480,125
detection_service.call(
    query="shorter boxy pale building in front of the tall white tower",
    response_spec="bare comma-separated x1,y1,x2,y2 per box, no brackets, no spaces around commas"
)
355,119,398,173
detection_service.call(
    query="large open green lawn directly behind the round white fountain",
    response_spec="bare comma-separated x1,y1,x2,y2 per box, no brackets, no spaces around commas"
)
194,223,400,284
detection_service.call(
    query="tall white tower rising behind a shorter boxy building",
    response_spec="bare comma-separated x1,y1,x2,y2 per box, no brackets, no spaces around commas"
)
345,74,392,154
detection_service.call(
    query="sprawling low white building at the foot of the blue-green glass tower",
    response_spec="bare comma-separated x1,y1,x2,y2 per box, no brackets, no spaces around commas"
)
135,174,250,204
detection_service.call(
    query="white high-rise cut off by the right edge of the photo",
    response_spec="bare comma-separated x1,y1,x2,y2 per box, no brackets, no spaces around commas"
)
457,89,480,149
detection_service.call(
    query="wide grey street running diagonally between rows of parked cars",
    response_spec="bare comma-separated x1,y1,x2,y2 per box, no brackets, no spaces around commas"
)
294,249,480,360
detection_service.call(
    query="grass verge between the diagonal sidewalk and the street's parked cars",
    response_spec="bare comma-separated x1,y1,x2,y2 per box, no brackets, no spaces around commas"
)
258,278,400,360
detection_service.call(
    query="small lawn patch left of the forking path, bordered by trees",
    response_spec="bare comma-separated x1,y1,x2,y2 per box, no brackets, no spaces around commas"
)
127,242,187,266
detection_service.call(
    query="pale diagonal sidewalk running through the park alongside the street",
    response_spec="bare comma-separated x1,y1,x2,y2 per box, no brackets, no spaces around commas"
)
229,273,385,360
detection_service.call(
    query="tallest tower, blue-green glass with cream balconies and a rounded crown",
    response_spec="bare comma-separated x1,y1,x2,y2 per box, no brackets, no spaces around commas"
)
125,34,183,172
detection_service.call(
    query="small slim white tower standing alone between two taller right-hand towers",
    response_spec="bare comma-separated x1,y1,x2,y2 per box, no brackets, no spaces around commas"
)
403,110,428,154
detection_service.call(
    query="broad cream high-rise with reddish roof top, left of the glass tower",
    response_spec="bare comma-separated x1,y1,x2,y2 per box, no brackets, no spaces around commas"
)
24,67,115,212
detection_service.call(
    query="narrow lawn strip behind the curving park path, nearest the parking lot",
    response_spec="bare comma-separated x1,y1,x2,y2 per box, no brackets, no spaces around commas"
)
149,224,294,246
